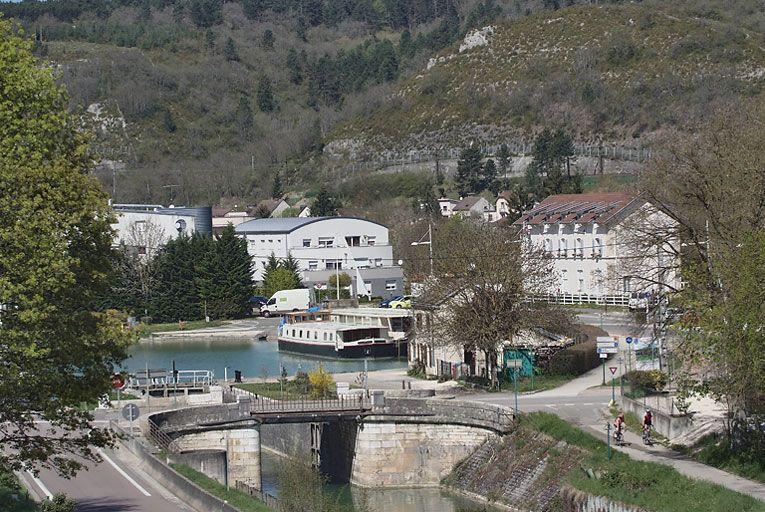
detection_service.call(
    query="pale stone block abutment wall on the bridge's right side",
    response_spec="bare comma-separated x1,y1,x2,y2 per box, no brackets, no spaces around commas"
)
351,421,496,487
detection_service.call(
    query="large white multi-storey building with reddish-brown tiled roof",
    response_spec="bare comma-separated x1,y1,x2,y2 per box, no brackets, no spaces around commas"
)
514,192,679,304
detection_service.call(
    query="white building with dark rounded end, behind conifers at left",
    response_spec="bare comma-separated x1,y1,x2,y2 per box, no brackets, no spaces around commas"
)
111,204,212,255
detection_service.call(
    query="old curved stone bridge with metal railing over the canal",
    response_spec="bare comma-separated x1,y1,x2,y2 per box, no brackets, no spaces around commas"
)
148,395,515,488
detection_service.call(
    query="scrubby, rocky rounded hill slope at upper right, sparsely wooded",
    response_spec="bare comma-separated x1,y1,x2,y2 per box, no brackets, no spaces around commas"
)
328,4,765,158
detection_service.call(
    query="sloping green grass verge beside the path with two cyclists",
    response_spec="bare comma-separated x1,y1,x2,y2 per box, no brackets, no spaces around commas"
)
521,412,765,512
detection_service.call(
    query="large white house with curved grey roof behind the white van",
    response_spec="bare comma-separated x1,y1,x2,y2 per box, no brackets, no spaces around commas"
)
235,217,403,297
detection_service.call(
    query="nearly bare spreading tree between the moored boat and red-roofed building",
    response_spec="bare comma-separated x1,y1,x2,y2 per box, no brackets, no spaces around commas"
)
419,220,568,381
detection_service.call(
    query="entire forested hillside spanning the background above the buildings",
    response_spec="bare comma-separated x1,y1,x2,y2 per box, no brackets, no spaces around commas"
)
0,0,765,204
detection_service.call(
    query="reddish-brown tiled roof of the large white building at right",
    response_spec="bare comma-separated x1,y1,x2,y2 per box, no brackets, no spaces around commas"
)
513,192,642,226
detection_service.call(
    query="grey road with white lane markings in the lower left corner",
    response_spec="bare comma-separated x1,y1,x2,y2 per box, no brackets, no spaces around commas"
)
21,424,193,512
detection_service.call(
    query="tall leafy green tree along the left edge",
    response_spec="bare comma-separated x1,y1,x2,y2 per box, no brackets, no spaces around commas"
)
0,19,130,475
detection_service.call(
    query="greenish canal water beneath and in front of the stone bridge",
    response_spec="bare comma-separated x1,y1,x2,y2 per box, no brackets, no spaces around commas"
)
261,451,498,512
